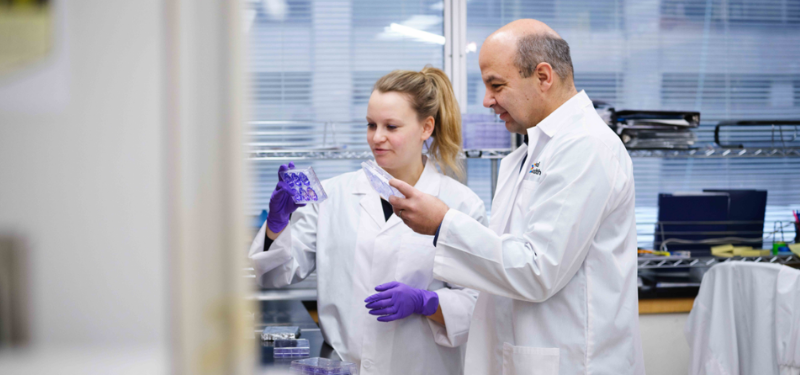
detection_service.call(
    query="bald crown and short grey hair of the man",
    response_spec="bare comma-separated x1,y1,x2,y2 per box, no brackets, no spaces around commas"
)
481,19,573,82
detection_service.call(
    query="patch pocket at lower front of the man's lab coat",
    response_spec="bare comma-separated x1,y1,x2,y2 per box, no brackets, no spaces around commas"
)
503,342,559,375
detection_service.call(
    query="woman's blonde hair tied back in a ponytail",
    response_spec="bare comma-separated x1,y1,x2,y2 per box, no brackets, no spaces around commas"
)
373,65,464,179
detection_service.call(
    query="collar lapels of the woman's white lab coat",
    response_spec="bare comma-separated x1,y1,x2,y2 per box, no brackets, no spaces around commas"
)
353,156,442,231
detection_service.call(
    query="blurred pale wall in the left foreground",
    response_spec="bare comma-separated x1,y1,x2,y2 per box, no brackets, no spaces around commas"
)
0,0,168,346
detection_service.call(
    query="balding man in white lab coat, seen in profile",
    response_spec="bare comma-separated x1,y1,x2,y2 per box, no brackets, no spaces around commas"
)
391,20,644,375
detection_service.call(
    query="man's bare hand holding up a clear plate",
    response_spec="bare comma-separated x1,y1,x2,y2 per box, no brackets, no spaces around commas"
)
389,179,450,235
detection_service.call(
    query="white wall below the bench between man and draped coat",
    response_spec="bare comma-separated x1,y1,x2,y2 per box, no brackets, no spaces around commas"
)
639,313,689,375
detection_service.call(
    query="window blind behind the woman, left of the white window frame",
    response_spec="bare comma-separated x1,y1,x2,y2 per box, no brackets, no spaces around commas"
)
244,0,444,215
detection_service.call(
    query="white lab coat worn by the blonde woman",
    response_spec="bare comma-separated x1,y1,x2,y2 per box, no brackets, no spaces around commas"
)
250,161,486,375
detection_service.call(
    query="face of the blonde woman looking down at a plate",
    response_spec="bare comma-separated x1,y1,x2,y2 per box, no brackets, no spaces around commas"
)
367,90,434,171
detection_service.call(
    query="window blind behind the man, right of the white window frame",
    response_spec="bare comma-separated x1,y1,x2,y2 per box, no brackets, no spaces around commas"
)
467,0,800,248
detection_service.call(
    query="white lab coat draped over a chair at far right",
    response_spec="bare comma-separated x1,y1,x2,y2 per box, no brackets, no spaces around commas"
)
685,262,800,375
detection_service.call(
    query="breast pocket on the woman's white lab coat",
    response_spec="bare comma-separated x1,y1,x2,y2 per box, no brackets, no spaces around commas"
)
395,234,436,289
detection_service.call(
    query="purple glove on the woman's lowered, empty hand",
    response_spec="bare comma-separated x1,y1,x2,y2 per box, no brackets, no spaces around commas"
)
364,281,439,322
